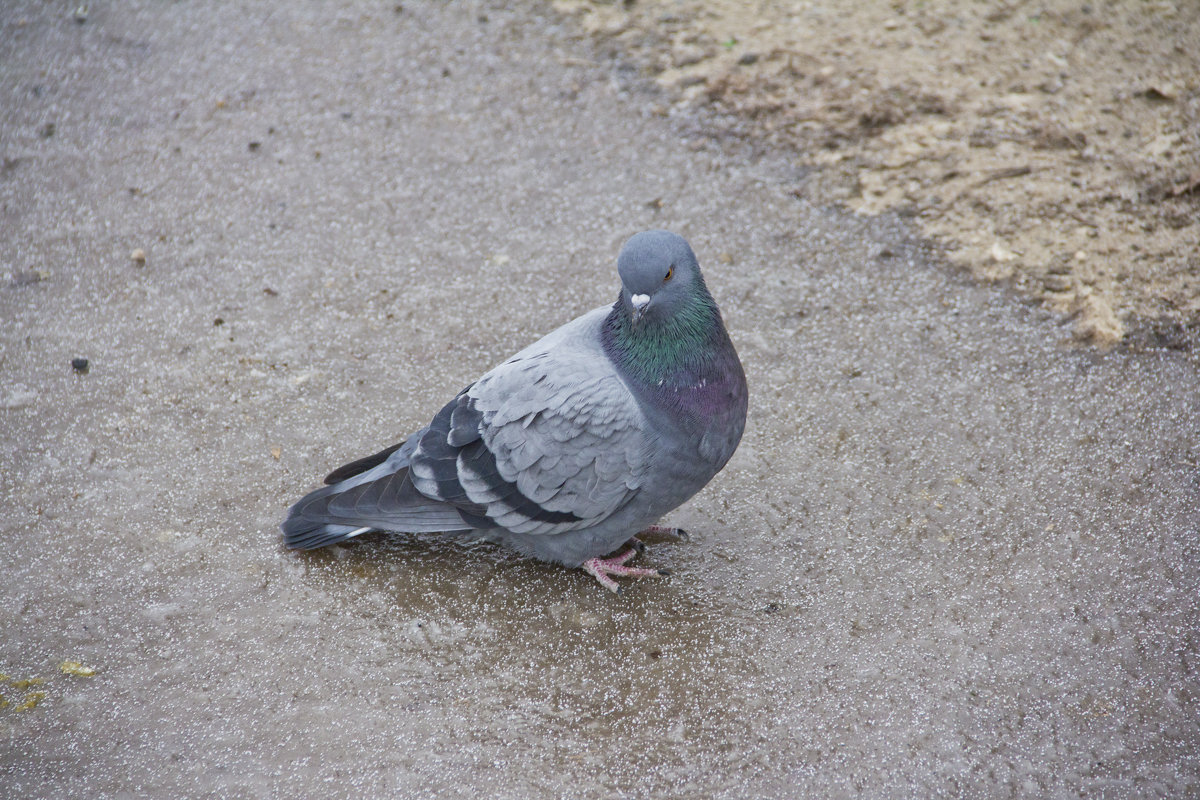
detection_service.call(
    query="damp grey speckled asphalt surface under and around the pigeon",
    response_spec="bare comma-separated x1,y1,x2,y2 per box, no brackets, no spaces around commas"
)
0,0,1200,798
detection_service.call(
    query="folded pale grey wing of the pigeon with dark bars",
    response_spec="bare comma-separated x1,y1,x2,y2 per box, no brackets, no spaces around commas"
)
409,316,646,534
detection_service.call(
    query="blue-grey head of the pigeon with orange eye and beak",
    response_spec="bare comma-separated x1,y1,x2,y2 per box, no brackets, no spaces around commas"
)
617,230,708,325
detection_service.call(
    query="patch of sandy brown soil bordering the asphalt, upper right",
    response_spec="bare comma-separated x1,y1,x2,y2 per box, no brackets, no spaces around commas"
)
556,0,1200,348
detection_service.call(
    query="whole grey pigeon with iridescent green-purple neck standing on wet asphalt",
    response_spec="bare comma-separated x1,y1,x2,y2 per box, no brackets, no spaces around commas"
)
283,230,746,591
